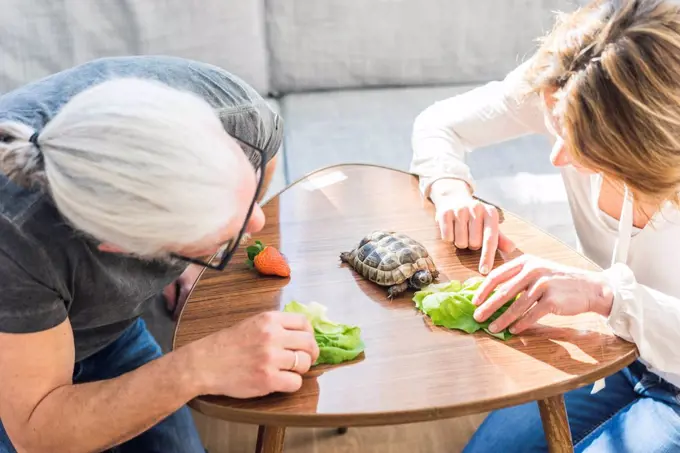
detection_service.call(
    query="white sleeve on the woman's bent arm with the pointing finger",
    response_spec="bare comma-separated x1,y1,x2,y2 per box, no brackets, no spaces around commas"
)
410,57,548,197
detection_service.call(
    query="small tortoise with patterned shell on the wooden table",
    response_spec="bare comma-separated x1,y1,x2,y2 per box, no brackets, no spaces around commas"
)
340,230,439,299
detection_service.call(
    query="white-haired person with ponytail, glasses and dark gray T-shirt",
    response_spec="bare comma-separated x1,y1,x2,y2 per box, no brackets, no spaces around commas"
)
0,57,318,453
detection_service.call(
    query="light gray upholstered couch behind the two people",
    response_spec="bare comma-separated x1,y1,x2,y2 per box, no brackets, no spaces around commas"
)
0,0,585,347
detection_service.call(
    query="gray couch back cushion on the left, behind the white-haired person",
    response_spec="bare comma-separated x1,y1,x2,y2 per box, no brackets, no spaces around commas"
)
0,0,269,93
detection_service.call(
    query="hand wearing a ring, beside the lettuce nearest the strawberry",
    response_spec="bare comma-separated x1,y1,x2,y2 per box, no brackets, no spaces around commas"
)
190,311,319,398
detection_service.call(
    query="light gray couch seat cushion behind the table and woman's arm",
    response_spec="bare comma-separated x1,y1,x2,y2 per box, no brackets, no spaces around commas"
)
282,86,575,245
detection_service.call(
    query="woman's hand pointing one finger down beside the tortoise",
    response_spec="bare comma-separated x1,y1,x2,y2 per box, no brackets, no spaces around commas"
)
431,180,515,275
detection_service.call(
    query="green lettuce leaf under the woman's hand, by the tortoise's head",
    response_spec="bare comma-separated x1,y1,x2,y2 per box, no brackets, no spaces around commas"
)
413,277,517,340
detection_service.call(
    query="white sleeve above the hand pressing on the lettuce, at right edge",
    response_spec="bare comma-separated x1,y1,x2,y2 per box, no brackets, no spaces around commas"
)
603,263,680,385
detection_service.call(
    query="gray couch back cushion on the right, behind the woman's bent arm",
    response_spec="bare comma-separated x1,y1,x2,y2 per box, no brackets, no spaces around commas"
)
267,0,584,92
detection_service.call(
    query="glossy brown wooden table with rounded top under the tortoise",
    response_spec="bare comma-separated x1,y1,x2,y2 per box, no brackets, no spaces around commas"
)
174,165,637,453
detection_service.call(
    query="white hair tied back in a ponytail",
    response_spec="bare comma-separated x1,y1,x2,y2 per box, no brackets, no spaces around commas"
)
0,79,245,256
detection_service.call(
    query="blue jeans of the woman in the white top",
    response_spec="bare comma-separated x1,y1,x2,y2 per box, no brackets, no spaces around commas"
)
463,362,680,453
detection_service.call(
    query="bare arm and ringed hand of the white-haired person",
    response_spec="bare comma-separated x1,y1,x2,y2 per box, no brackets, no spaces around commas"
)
0,312,319,453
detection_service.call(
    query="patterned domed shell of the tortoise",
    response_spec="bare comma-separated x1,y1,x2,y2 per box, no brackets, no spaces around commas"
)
354,231,431,285
